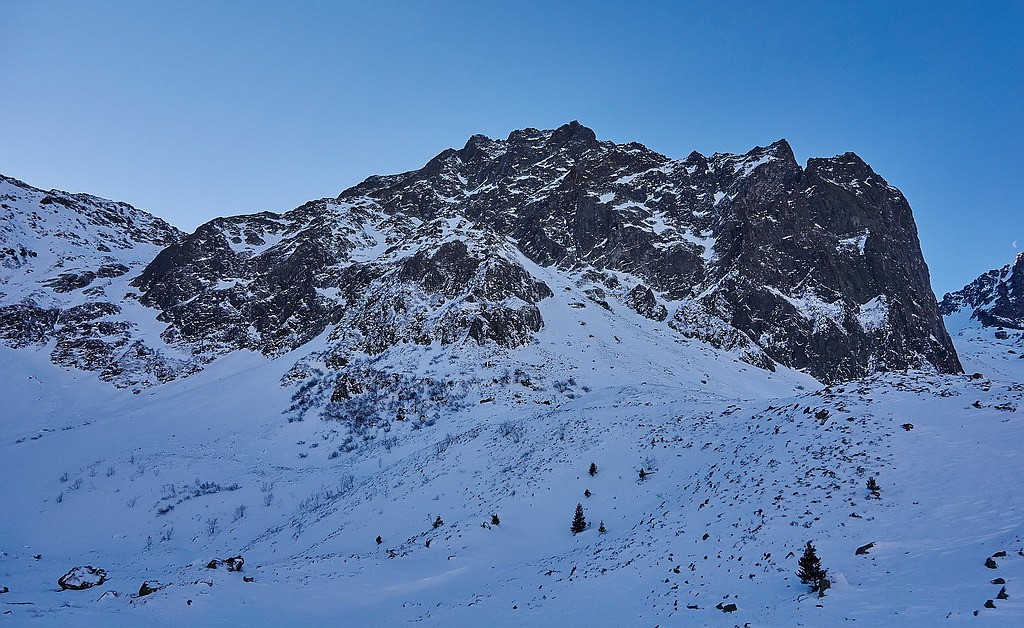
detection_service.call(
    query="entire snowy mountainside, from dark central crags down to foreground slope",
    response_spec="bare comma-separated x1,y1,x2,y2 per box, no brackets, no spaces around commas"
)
0,123,1024,626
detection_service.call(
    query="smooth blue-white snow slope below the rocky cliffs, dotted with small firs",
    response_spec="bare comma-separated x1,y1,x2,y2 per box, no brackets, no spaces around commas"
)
0,292,1024,626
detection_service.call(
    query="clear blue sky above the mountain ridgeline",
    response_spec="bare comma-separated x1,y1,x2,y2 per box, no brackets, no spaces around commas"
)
0,0,1024,296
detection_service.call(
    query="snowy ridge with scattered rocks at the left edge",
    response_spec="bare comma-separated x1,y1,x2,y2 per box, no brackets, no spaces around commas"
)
0,171,190,387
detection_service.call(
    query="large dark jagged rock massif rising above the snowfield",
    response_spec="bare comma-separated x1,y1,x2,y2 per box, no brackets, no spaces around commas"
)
134,122,961,381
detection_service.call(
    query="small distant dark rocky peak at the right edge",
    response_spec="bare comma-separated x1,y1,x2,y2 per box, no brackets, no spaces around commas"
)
940,253,1024,330
